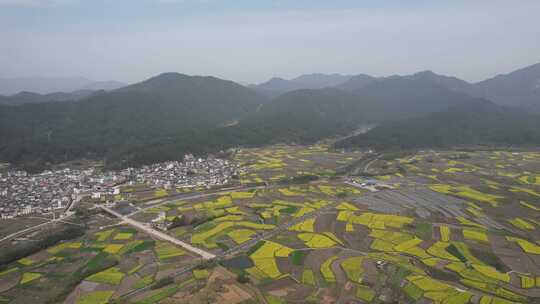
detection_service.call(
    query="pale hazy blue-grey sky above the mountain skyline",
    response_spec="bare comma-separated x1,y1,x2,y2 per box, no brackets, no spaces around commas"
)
0,0,540,83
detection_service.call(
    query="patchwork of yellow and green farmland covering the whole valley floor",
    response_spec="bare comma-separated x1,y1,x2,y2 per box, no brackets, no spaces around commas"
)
0,145,540,304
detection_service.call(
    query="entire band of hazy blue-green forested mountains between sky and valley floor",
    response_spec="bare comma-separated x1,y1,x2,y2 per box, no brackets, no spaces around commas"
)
0,65,540,170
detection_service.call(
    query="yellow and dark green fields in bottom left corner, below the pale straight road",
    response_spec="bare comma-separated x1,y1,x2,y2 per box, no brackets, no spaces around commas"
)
0,218,196,303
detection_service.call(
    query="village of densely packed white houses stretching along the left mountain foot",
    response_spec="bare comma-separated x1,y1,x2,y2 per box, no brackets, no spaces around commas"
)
0,155,239,219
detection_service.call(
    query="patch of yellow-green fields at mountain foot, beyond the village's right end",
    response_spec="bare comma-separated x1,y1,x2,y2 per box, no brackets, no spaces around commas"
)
234,144,363,184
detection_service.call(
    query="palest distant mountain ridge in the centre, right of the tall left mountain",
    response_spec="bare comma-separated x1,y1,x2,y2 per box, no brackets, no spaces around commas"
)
250,73,351,97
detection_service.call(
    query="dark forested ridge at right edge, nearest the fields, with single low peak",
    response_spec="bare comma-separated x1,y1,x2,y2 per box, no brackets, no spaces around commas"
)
336,99,540,150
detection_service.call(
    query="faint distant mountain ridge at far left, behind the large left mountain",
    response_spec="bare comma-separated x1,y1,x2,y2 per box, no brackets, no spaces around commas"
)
0,90,100,105
